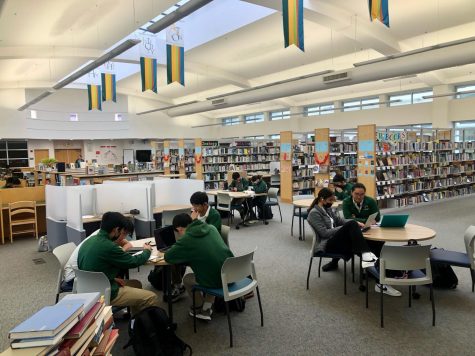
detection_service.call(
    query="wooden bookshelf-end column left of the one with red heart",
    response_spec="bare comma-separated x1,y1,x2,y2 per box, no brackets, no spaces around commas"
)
280,131,293,203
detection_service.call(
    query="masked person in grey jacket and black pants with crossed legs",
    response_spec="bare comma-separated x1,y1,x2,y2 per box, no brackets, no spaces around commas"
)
307,188,401,296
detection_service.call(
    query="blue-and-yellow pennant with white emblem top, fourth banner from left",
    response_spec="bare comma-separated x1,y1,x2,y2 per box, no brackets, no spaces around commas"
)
167,25,185,86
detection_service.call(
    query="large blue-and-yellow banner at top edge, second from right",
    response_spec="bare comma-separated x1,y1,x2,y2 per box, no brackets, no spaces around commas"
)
282,0,305,52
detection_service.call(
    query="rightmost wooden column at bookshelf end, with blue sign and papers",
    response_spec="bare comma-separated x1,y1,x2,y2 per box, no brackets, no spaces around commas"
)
358,125,376,199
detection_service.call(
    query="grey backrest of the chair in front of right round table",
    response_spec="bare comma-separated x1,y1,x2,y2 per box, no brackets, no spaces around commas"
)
380,245,431,276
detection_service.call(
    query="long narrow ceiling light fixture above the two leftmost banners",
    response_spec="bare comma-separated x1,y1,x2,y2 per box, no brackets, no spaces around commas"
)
18,39,140,111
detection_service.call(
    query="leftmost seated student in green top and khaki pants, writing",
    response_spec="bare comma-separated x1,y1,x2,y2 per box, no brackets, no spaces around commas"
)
78,212,160,316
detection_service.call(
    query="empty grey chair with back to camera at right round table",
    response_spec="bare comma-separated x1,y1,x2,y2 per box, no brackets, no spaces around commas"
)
366,245,435,328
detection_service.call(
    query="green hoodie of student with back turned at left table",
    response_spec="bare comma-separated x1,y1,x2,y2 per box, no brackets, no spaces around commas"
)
165,220,234,288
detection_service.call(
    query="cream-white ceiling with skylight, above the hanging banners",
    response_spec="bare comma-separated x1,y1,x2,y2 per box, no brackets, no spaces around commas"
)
0,0,475,117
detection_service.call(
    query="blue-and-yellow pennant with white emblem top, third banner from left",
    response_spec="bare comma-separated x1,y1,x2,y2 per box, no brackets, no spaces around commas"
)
140,35,157,93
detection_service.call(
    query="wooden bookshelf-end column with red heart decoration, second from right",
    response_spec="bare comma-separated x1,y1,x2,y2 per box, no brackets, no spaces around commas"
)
315,129,330,196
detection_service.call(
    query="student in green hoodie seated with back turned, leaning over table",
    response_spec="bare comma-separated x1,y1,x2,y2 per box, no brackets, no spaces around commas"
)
165,211,234,320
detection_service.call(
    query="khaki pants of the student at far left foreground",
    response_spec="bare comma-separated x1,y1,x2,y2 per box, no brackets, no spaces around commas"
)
111,279,160,316
